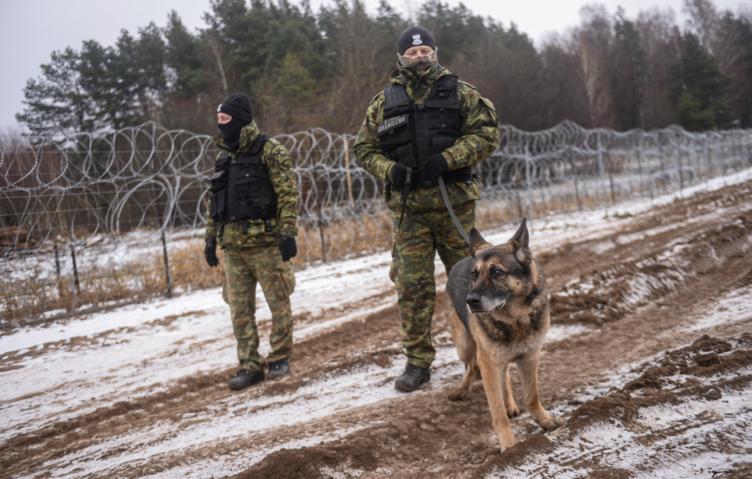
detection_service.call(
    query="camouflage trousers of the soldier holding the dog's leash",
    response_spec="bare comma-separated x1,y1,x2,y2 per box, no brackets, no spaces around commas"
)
389,201,475,368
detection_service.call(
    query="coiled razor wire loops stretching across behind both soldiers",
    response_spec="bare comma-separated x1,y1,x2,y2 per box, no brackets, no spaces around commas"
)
0,121,752,256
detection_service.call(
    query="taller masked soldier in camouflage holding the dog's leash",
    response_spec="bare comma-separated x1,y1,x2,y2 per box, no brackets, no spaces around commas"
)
354,26,499,392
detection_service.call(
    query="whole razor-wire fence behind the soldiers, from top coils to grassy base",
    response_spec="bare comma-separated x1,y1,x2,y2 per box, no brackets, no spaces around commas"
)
0,122,752,320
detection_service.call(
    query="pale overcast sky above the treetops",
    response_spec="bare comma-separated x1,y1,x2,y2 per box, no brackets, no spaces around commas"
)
0,0,752,129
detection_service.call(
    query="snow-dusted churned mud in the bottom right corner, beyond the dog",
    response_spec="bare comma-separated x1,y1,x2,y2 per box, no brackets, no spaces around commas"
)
473,333,752,479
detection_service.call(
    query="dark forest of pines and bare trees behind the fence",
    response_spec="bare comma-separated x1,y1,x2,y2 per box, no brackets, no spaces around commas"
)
17,0,752,138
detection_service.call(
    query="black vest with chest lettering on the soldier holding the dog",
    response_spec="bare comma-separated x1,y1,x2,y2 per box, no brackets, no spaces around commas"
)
376,75,472,187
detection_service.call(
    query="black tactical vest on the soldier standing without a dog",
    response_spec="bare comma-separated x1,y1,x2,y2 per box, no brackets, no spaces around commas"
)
209,135,277,223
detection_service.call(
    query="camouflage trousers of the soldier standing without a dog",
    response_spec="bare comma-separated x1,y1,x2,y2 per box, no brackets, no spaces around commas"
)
223,244,295,371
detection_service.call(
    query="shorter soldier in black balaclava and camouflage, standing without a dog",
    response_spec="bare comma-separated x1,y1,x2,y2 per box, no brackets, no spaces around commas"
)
204,95,298,390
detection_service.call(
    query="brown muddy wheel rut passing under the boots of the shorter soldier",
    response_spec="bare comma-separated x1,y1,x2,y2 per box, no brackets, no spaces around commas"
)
0,305,406,473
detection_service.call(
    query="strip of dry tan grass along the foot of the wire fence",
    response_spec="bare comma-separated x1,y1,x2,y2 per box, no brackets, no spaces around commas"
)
0,188,640,326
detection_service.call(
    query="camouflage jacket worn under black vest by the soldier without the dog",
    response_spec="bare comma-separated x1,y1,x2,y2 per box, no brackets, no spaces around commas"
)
206,121,298,248
